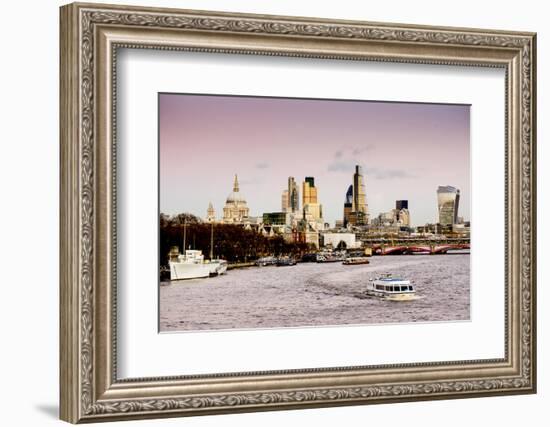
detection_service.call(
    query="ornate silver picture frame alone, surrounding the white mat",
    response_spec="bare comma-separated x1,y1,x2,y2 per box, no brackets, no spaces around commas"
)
60,3,536,423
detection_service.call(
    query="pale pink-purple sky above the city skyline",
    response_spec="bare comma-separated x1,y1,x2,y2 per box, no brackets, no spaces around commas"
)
159,94,470,225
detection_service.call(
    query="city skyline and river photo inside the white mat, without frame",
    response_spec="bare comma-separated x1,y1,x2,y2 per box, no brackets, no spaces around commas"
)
158,93,471,332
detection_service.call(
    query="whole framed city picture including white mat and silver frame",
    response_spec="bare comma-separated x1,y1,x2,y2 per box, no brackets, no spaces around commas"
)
59,3,537,423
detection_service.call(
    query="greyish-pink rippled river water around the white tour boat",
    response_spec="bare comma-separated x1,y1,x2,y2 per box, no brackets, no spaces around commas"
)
159,254,470,332
